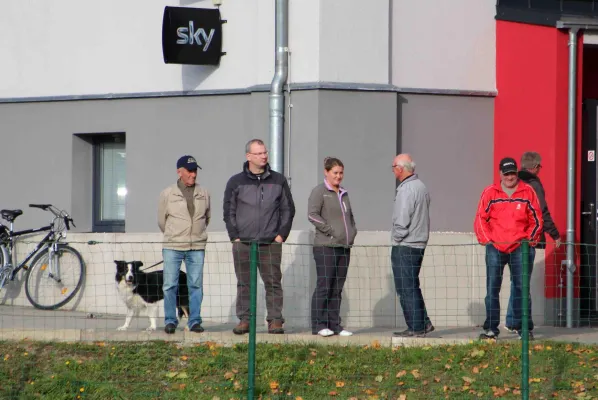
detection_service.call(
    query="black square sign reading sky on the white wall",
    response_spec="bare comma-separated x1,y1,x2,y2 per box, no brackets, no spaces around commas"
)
162,7,223,65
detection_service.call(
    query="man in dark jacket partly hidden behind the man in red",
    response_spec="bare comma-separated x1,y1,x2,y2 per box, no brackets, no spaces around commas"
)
505,151,561,332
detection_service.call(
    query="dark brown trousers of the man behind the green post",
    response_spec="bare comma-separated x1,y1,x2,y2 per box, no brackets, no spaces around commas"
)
233,242,284,323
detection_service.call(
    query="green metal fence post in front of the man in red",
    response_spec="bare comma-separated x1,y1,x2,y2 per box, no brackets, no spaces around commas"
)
521,240,530,400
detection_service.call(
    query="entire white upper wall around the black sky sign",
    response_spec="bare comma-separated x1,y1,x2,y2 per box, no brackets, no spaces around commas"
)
0,0,496,99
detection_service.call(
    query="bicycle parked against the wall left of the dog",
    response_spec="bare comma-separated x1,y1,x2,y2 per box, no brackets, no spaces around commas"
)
0,204,86,310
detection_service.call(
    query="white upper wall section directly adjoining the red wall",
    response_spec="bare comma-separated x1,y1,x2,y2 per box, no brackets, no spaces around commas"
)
394,0,496,91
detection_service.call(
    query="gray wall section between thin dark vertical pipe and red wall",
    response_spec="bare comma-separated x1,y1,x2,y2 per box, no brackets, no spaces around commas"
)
398,94,496,232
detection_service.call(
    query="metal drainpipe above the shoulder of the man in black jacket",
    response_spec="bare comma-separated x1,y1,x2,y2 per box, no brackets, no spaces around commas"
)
270,0,289,174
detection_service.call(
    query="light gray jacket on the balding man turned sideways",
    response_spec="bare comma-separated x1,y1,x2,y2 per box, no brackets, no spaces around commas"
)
391,174,430,249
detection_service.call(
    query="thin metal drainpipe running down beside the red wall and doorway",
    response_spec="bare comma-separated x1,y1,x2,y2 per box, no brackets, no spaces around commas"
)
566,28,578,328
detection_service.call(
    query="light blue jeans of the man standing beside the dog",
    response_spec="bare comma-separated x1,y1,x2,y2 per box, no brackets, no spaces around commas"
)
162,249,206,328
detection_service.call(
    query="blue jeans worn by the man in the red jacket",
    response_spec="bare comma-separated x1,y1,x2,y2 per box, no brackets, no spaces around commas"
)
484,244,536,335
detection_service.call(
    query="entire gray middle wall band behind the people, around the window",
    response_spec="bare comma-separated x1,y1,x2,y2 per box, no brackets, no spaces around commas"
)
0,90,493,233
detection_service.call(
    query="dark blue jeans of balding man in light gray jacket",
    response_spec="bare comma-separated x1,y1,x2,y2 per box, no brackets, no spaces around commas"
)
390,246,431,332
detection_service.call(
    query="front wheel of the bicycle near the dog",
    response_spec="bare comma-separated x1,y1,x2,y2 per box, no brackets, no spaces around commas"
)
25,245,85,310
